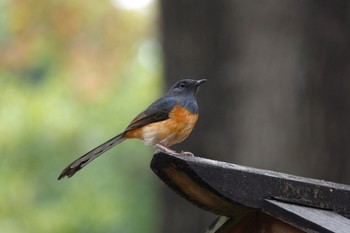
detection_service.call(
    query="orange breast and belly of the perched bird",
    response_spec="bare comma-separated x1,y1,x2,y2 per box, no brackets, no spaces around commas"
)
124,105,198,147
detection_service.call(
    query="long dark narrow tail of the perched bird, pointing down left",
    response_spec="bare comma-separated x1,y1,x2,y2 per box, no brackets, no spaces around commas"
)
58,132,125,180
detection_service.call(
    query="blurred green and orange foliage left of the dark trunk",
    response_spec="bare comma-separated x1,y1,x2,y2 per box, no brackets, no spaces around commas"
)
0,0,161,233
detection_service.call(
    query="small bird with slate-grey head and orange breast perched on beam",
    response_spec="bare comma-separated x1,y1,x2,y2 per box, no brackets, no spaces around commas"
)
58,79,207,180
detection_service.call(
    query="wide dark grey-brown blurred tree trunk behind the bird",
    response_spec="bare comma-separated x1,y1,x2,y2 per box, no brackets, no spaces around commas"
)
160,0,350,233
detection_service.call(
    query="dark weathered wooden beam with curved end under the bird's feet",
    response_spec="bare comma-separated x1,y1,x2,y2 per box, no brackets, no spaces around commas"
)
151,153,350,218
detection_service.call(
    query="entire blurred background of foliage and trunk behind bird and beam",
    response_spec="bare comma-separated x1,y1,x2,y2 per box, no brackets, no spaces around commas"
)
0,0,350,233
